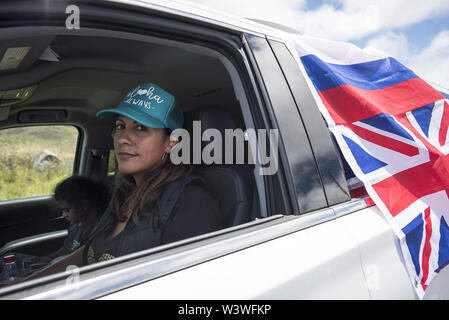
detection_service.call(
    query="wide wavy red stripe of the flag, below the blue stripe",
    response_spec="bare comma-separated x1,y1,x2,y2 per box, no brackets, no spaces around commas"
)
318,78,444,125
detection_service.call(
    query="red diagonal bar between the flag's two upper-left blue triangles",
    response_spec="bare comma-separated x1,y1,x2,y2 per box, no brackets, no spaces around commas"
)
348,125,419,157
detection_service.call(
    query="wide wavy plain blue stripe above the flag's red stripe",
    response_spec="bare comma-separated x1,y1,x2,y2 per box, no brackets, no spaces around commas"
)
301,55,418,91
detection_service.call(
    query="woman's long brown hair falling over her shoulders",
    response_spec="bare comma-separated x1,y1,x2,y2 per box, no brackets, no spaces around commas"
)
111,136,192,225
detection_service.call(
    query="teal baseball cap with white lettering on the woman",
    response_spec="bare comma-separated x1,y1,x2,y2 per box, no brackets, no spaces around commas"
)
97,83,184,131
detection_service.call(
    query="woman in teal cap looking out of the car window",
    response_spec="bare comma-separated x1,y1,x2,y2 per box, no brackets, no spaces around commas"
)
29,83,223,276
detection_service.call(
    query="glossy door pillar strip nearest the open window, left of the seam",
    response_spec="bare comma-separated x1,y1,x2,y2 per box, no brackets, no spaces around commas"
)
245,34,327,214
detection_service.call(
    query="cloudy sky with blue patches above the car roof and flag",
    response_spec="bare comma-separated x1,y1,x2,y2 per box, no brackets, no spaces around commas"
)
187,0,449,88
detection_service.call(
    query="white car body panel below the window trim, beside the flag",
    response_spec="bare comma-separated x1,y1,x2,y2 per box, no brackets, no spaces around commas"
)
102,207,416,299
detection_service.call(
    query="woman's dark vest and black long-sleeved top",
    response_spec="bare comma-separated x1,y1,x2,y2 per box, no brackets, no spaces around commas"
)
84,174,223,264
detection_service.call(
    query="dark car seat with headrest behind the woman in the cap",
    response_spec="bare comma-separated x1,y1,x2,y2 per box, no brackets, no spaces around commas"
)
184,106,256,227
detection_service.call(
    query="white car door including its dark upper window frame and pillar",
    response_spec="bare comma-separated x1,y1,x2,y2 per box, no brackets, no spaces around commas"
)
0,3,402,299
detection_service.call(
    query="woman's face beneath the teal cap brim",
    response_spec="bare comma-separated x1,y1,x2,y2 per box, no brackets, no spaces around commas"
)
113,115,170,184
